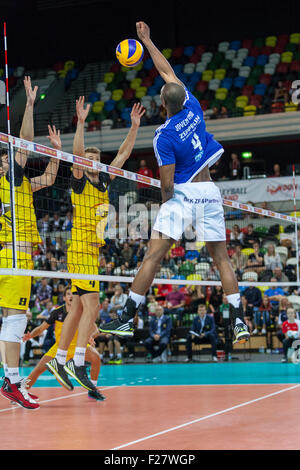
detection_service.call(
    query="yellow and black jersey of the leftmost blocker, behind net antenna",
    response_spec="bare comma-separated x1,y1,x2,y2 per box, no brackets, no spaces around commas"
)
0,161,42,244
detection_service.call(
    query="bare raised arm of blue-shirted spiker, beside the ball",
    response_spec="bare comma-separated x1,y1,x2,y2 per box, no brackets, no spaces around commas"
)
136,21,184,86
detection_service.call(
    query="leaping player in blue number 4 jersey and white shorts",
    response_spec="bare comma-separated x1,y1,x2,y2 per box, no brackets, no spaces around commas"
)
100,22,250,343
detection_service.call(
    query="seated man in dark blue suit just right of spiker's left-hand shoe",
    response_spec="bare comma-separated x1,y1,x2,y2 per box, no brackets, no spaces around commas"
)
144,305,172,362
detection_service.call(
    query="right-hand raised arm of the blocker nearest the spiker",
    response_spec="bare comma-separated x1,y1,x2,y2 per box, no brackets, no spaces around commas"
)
110,103,145,179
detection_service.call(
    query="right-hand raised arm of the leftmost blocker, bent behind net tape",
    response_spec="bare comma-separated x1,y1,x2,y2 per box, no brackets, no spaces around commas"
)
30,126,61,192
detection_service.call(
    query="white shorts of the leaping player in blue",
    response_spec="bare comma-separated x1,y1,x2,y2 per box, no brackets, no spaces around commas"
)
153,181,226,242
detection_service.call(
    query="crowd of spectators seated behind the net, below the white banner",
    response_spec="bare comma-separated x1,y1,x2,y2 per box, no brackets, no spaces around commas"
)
11,207,300,364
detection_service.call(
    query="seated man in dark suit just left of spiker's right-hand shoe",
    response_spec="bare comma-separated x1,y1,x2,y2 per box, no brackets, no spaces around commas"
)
186,305,218,362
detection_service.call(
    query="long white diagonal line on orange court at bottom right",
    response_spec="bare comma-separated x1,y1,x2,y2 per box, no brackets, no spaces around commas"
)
111,384,300,450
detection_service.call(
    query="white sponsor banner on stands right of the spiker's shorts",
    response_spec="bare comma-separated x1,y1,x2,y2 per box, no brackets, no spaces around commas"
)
216,176,300,203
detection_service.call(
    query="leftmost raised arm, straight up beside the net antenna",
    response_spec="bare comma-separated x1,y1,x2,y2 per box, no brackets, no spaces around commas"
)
15,76,38,168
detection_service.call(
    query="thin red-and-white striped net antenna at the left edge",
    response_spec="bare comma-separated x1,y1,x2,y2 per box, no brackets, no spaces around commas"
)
4,22,17,269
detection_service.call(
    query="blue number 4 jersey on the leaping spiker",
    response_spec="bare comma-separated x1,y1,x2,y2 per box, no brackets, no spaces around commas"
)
153,89,224,184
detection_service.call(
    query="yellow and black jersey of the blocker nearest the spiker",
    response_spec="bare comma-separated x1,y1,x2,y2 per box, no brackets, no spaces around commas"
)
70,173,110,253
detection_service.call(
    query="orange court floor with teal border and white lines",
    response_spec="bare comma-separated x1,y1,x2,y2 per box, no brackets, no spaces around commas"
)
0,357,300,451
